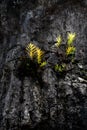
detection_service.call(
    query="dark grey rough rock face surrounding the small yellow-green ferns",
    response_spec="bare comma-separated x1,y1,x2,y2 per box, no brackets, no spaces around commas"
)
0,0,87,130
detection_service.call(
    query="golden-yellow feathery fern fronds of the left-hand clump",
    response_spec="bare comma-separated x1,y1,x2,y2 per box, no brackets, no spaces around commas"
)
26,43,46,66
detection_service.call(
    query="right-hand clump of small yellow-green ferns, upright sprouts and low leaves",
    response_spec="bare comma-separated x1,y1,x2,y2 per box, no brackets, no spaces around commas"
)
54,33,76,73
